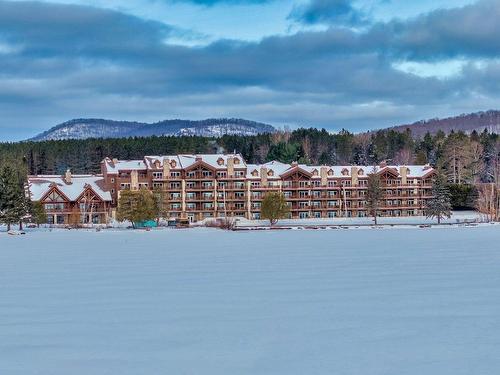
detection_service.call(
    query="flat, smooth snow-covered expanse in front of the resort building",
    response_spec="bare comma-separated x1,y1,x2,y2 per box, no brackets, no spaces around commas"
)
0,225,500,375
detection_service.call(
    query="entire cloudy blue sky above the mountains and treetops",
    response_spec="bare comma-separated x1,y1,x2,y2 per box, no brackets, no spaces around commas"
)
0,0,500,141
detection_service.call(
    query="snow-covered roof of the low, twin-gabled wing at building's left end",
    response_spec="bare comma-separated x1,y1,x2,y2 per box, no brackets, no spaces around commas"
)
28,175,111,201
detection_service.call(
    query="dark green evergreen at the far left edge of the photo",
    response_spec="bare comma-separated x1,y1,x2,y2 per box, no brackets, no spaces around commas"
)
0,165,27,230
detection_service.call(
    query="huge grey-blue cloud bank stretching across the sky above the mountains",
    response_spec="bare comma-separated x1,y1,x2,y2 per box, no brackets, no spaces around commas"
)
0,0,500,137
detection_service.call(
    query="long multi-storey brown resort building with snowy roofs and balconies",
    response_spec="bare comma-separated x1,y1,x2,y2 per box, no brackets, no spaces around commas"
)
28,154,435,224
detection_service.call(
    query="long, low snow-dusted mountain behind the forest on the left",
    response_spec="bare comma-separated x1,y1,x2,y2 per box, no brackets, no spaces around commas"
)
31,118,276,141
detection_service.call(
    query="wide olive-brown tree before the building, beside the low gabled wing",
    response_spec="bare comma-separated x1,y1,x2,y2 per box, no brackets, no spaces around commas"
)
116,189,158,228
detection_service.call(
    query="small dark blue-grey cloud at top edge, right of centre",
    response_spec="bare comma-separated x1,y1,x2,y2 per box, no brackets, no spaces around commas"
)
289,0,367,25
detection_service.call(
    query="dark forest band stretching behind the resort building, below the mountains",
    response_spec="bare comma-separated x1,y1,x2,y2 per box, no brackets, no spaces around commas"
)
0,129,500,183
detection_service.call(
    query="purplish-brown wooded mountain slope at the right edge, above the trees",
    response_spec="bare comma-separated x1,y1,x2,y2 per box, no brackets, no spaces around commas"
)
390,110,500,137
